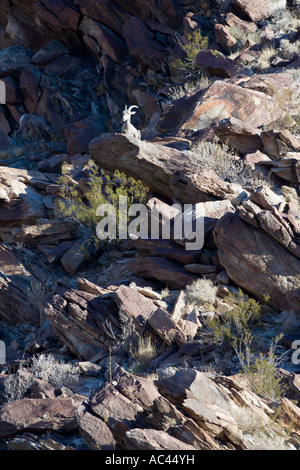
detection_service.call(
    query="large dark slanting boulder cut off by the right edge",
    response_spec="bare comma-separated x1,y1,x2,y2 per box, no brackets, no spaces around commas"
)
214,213,300,310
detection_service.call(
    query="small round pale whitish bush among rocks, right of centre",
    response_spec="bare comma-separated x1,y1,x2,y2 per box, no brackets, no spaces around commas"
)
185,278,217,308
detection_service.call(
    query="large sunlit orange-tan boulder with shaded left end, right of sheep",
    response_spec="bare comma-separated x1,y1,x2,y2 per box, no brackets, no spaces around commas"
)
155,78,292,136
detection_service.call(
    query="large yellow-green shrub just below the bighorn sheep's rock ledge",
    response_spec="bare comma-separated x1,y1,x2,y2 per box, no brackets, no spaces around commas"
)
57,165,149,248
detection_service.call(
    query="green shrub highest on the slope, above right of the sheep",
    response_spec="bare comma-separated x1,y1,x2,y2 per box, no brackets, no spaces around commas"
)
172,29,209,80
